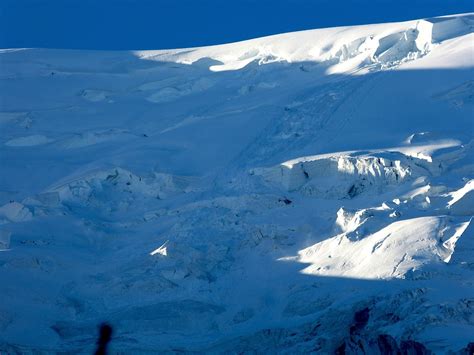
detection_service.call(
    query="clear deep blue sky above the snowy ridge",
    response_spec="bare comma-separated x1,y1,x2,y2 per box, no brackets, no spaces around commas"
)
0,0,474,49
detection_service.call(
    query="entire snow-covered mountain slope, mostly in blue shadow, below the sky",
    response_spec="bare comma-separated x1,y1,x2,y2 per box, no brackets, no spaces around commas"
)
0,14,474,354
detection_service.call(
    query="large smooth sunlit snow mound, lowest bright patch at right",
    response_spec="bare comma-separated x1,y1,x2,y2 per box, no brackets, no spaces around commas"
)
298,217,468,279
